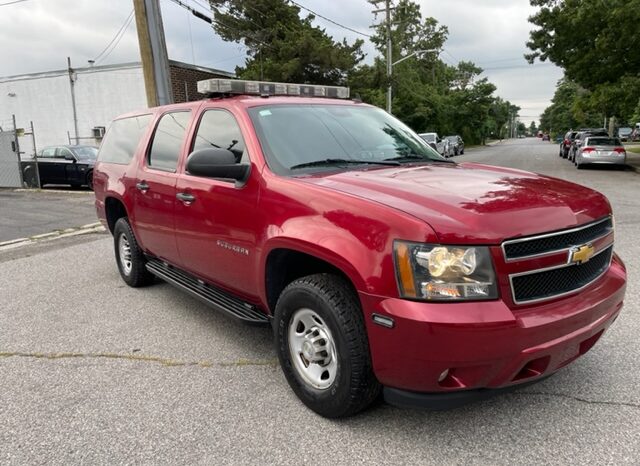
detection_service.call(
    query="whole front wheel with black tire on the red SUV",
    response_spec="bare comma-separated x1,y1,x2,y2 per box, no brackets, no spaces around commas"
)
274,274,380,418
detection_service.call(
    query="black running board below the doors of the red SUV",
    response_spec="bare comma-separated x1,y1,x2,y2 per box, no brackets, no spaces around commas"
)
147,259,269,324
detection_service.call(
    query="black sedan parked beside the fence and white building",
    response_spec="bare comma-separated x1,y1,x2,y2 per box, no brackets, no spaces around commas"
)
23,146,98,189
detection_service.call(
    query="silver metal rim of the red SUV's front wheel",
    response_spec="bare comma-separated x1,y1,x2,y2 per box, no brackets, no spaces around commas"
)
289,308,338,390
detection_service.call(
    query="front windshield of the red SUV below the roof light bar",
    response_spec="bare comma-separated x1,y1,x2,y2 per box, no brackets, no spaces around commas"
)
249,104,448,175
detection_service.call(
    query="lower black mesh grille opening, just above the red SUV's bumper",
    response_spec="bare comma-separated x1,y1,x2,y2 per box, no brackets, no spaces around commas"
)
511,245,613,304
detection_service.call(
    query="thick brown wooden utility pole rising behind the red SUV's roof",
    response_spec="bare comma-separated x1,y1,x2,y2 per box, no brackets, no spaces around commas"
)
133,0,173,107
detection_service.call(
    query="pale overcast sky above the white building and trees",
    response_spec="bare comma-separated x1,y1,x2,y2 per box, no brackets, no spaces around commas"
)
0,0,562,124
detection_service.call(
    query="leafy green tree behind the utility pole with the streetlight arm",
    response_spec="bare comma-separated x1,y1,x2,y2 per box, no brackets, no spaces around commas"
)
362,0,496,144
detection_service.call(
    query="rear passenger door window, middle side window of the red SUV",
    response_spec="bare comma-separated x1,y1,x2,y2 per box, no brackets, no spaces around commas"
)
148,112,191,171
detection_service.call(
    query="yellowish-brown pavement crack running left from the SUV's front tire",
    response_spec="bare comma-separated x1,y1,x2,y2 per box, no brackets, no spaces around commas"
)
0,351,278,368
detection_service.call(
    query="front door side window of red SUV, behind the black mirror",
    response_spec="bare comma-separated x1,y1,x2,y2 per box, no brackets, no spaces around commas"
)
191,110,249,163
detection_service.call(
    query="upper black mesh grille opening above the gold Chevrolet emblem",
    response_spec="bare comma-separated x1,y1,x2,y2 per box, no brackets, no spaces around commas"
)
502,217,613,260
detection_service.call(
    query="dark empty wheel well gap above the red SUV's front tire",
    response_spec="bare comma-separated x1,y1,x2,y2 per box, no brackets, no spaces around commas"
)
265,249,355,314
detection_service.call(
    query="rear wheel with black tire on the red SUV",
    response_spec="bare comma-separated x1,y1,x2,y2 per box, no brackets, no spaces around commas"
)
113,217,153,288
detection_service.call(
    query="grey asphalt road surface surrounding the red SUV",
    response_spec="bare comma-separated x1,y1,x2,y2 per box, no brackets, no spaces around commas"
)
0,139,640,465
